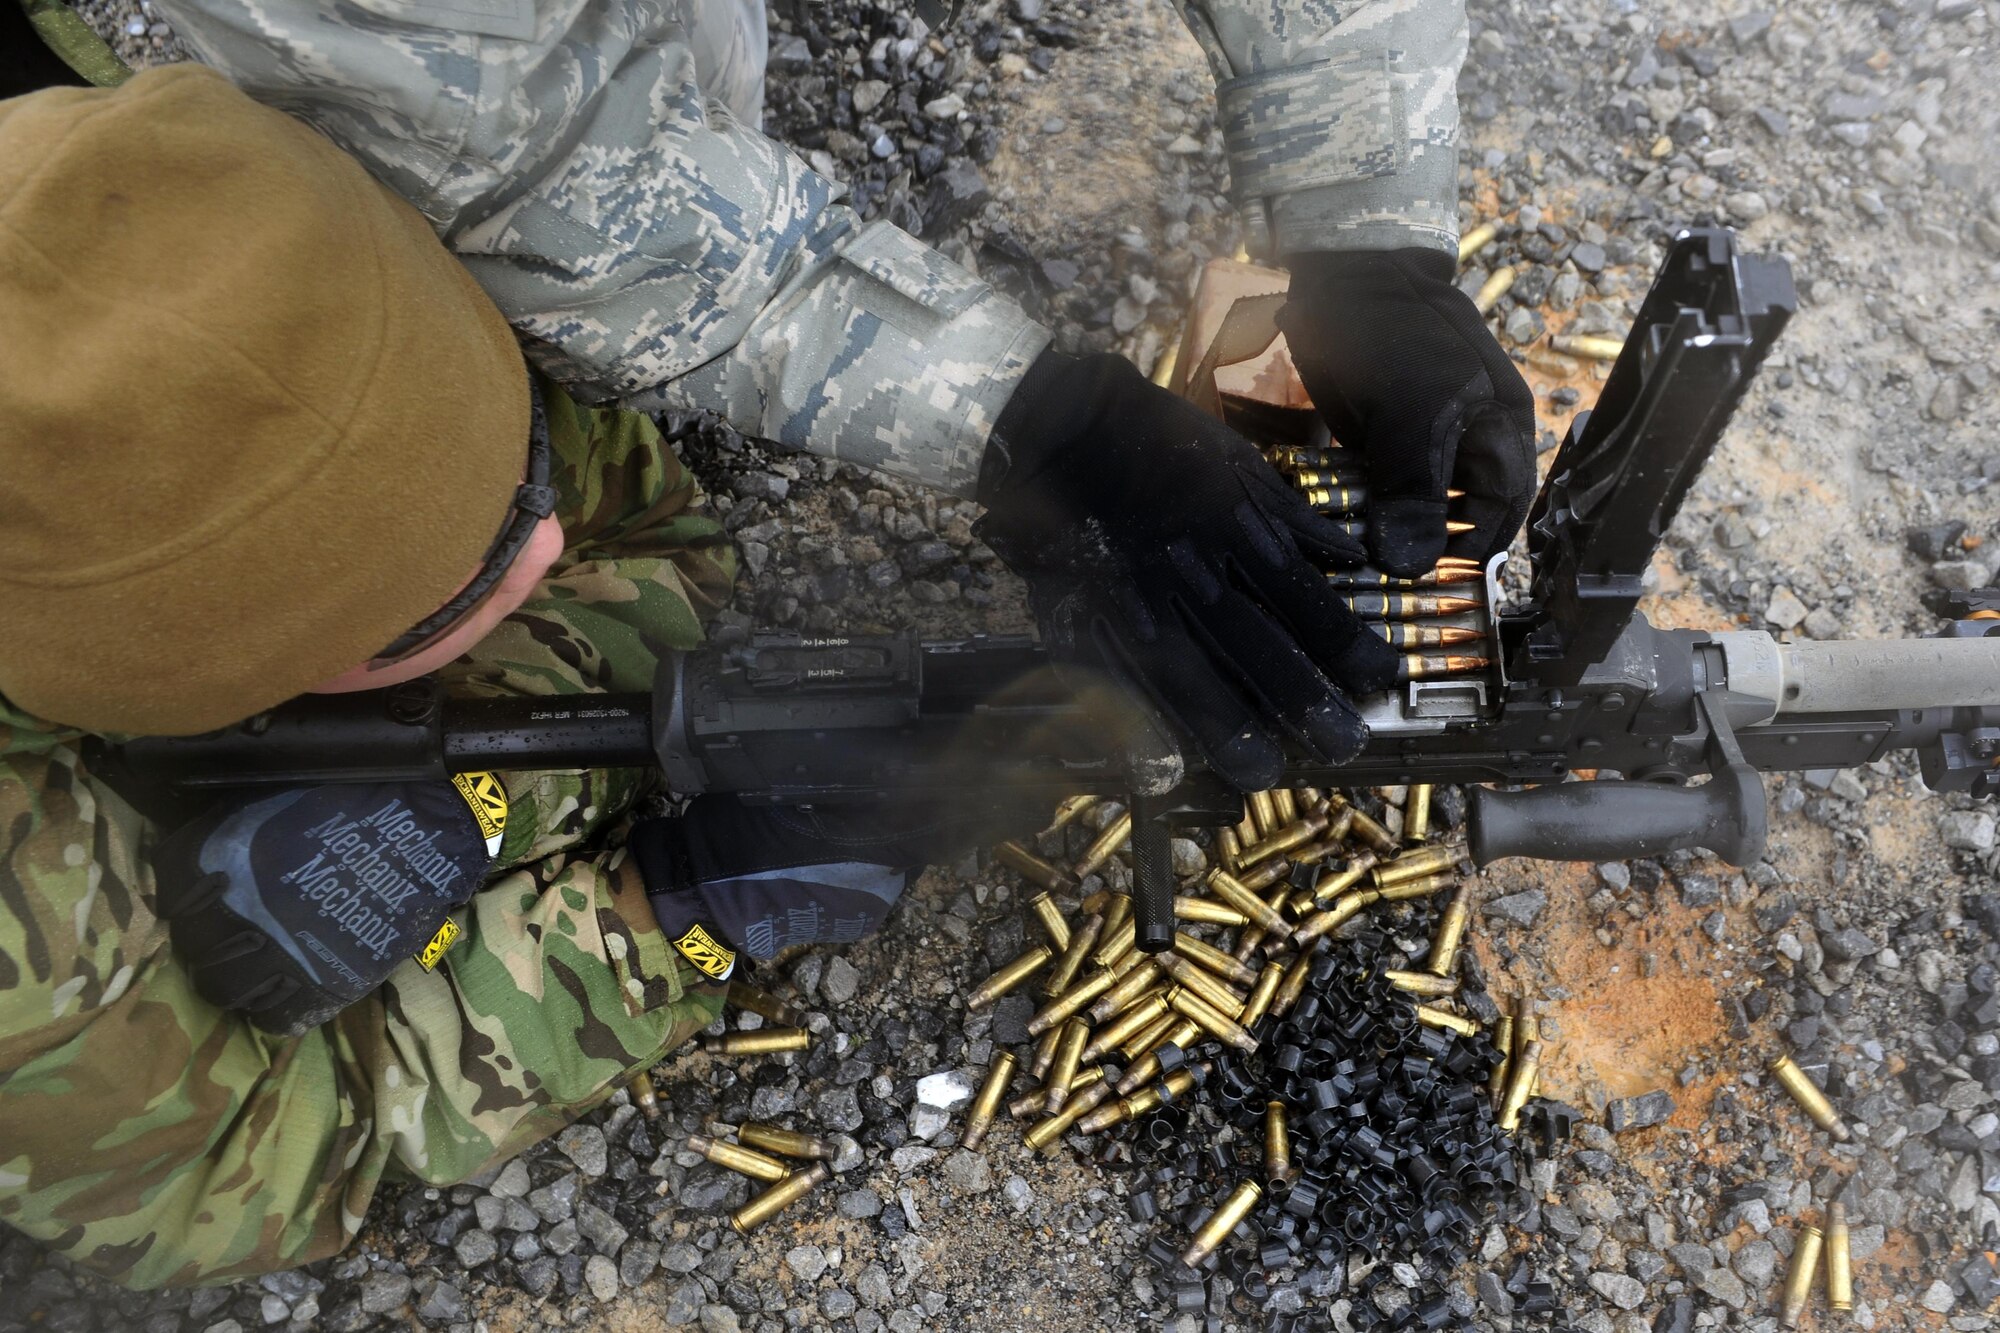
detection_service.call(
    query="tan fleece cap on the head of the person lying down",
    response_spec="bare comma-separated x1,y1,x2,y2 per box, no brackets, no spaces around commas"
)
0,67,530,735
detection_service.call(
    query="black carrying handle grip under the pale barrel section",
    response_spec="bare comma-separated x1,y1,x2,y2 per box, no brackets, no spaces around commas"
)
1466,767,1768,865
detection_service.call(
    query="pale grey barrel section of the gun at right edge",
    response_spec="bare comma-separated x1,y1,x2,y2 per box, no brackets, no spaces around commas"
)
1778,638,2000,717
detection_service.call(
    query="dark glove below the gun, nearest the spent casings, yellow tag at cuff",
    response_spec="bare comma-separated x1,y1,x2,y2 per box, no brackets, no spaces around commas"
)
626,797,1034,981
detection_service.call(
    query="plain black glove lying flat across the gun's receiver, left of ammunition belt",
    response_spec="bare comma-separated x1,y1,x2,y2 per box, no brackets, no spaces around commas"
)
976,352,1396,791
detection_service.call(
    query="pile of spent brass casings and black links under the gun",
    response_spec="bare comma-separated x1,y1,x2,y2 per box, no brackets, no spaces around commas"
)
962,787,1574,1329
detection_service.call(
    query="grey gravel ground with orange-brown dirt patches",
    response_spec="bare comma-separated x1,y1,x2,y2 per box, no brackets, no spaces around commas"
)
0,0,2000,1333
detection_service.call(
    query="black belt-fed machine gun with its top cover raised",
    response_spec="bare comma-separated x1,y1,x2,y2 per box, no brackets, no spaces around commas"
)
86,230,2000,949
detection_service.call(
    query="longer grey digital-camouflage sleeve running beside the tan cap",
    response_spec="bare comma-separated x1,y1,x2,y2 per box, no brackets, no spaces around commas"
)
148,0,1048,494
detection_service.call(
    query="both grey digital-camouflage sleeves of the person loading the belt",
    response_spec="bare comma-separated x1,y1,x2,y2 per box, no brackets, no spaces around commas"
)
158,0,1464,494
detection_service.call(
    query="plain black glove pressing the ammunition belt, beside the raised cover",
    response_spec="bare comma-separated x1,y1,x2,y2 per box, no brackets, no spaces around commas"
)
1278,248,1534,574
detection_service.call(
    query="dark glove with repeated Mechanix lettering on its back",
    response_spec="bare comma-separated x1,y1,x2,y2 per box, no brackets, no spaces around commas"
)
152,775,506,1037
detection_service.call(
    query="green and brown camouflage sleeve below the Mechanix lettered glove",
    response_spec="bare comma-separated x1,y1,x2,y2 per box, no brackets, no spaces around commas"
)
0,701,720,1287
